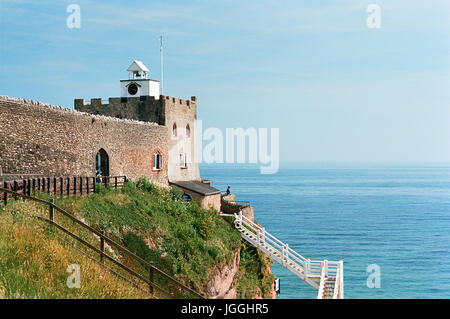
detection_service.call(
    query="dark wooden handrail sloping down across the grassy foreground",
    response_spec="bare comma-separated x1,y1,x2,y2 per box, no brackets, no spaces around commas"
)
0,187,204,299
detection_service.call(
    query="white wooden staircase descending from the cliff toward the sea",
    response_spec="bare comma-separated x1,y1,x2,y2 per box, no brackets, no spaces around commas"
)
234,211,344,299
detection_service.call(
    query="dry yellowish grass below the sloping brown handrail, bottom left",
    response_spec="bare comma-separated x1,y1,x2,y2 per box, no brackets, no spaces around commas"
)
0,202,149,298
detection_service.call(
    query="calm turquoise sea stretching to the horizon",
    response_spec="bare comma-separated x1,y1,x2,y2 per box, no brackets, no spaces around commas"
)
201,165,450,298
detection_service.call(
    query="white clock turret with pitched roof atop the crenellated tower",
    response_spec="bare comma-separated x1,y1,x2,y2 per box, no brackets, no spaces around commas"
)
120,60,159,100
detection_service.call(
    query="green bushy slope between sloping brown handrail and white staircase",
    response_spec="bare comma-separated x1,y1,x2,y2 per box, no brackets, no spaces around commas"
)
0,180,274,298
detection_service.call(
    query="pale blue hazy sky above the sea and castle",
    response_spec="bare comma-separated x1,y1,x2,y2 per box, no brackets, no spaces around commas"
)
0,0,450,162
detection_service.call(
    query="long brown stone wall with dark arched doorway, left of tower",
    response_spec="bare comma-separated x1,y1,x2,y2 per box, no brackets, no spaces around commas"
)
0,97,168,185
